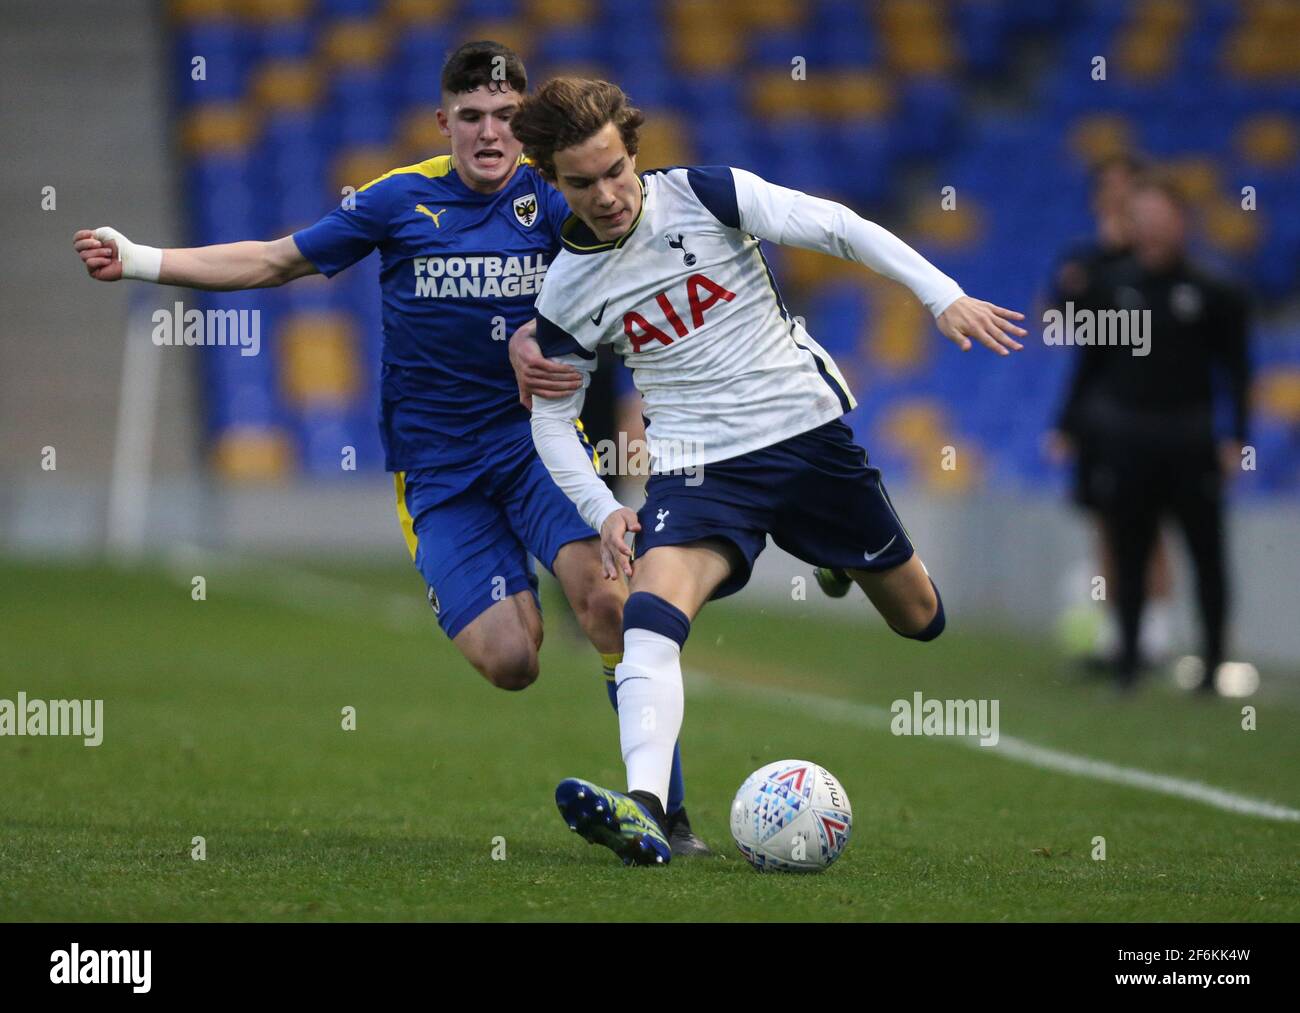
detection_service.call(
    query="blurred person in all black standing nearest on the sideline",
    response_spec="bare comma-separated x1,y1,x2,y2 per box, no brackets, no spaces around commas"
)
1066,176,1251,689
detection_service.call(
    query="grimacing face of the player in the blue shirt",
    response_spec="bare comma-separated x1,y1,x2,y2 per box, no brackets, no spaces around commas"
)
438,85,523,194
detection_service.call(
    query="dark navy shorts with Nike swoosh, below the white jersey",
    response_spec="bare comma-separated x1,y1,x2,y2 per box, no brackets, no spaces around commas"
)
636,419,915,598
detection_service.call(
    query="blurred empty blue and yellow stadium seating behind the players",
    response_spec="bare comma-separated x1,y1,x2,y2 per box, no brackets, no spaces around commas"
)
170,0,1300,494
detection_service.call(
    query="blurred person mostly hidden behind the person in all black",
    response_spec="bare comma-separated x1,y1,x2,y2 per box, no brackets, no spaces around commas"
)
1048,155,1174,671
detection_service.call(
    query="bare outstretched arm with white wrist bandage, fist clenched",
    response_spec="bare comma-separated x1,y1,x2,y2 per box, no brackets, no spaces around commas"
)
73,226,317,291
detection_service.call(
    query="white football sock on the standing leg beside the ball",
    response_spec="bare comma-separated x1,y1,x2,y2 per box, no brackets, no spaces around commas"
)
614,629,684,809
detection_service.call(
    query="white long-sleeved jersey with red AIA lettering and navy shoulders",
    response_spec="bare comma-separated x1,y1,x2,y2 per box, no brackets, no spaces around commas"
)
533,166,962,529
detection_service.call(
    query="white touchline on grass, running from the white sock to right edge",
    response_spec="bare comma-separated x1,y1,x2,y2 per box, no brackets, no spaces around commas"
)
686,670,1300,823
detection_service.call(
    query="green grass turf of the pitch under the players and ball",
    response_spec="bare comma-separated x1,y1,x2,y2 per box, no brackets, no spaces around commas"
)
0,560,1300,921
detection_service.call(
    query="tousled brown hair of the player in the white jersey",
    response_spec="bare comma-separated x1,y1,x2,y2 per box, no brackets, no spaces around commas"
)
510,78,645,183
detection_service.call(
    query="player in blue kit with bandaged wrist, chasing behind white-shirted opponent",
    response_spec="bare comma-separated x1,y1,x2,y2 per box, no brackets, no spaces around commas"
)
74,42,707,854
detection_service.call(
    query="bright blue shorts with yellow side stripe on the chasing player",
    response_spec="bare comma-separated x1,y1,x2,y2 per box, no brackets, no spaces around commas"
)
393,425,597,637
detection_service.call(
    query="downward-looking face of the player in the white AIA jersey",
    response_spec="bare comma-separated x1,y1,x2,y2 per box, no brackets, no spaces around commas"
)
555,124,641,242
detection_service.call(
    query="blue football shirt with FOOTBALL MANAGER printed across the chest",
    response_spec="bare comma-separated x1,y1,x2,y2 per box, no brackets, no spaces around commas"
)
294,155,569,471
